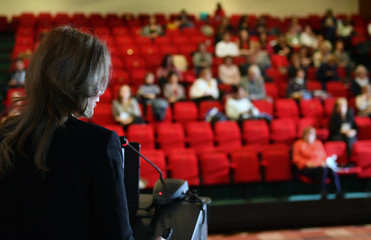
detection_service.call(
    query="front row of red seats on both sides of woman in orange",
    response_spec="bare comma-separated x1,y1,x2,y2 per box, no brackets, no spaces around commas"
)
134,141,371,188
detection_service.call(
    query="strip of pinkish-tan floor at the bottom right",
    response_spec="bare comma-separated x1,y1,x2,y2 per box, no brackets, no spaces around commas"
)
208,225,371,240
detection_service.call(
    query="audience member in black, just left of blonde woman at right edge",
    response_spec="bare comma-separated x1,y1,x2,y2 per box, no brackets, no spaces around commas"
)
316,54,340,91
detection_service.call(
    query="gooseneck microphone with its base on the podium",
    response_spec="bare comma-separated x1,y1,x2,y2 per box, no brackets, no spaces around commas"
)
120,136,189,205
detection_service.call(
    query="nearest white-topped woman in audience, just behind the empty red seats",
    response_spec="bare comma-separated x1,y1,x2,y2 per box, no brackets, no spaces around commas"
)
225,87,272,122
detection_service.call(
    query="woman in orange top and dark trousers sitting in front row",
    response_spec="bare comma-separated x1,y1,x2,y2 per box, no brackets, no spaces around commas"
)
292,127,343,199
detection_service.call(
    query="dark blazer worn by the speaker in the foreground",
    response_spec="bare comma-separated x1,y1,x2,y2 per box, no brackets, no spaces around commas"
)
0,117,136,240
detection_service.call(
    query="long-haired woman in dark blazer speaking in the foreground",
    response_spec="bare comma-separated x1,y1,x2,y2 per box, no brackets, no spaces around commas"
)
0,27,142,240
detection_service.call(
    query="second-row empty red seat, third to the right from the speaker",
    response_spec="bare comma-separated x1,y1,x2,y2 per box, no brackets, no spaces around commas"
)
185,122,214,152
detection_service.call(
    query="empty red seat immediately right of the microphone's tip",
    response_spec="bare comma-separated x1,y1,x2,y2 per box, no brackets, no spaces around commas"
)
127,124,155,149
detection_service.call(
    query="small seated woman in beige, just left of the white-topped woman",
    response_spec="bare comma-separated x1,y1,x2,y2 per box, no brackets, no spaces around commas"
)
164,72,186,103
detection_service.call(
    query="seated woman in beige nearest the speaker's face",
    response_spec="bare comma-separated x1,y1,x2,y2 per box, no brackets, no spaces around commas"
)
112,85,144,130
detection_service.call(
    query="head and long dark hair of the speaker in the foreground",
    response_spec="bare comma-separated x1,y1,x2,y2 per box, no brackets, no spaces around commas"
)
0,27,111,174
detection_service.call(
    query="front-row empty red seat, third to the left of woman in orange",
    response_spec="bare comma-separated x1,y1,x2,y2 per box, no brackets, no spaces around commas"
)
200,152,230,185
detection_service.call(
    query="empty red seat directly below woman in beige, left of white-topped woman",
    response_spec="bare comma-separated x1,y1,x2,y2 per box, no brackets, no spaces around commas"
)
173,101,198,124
